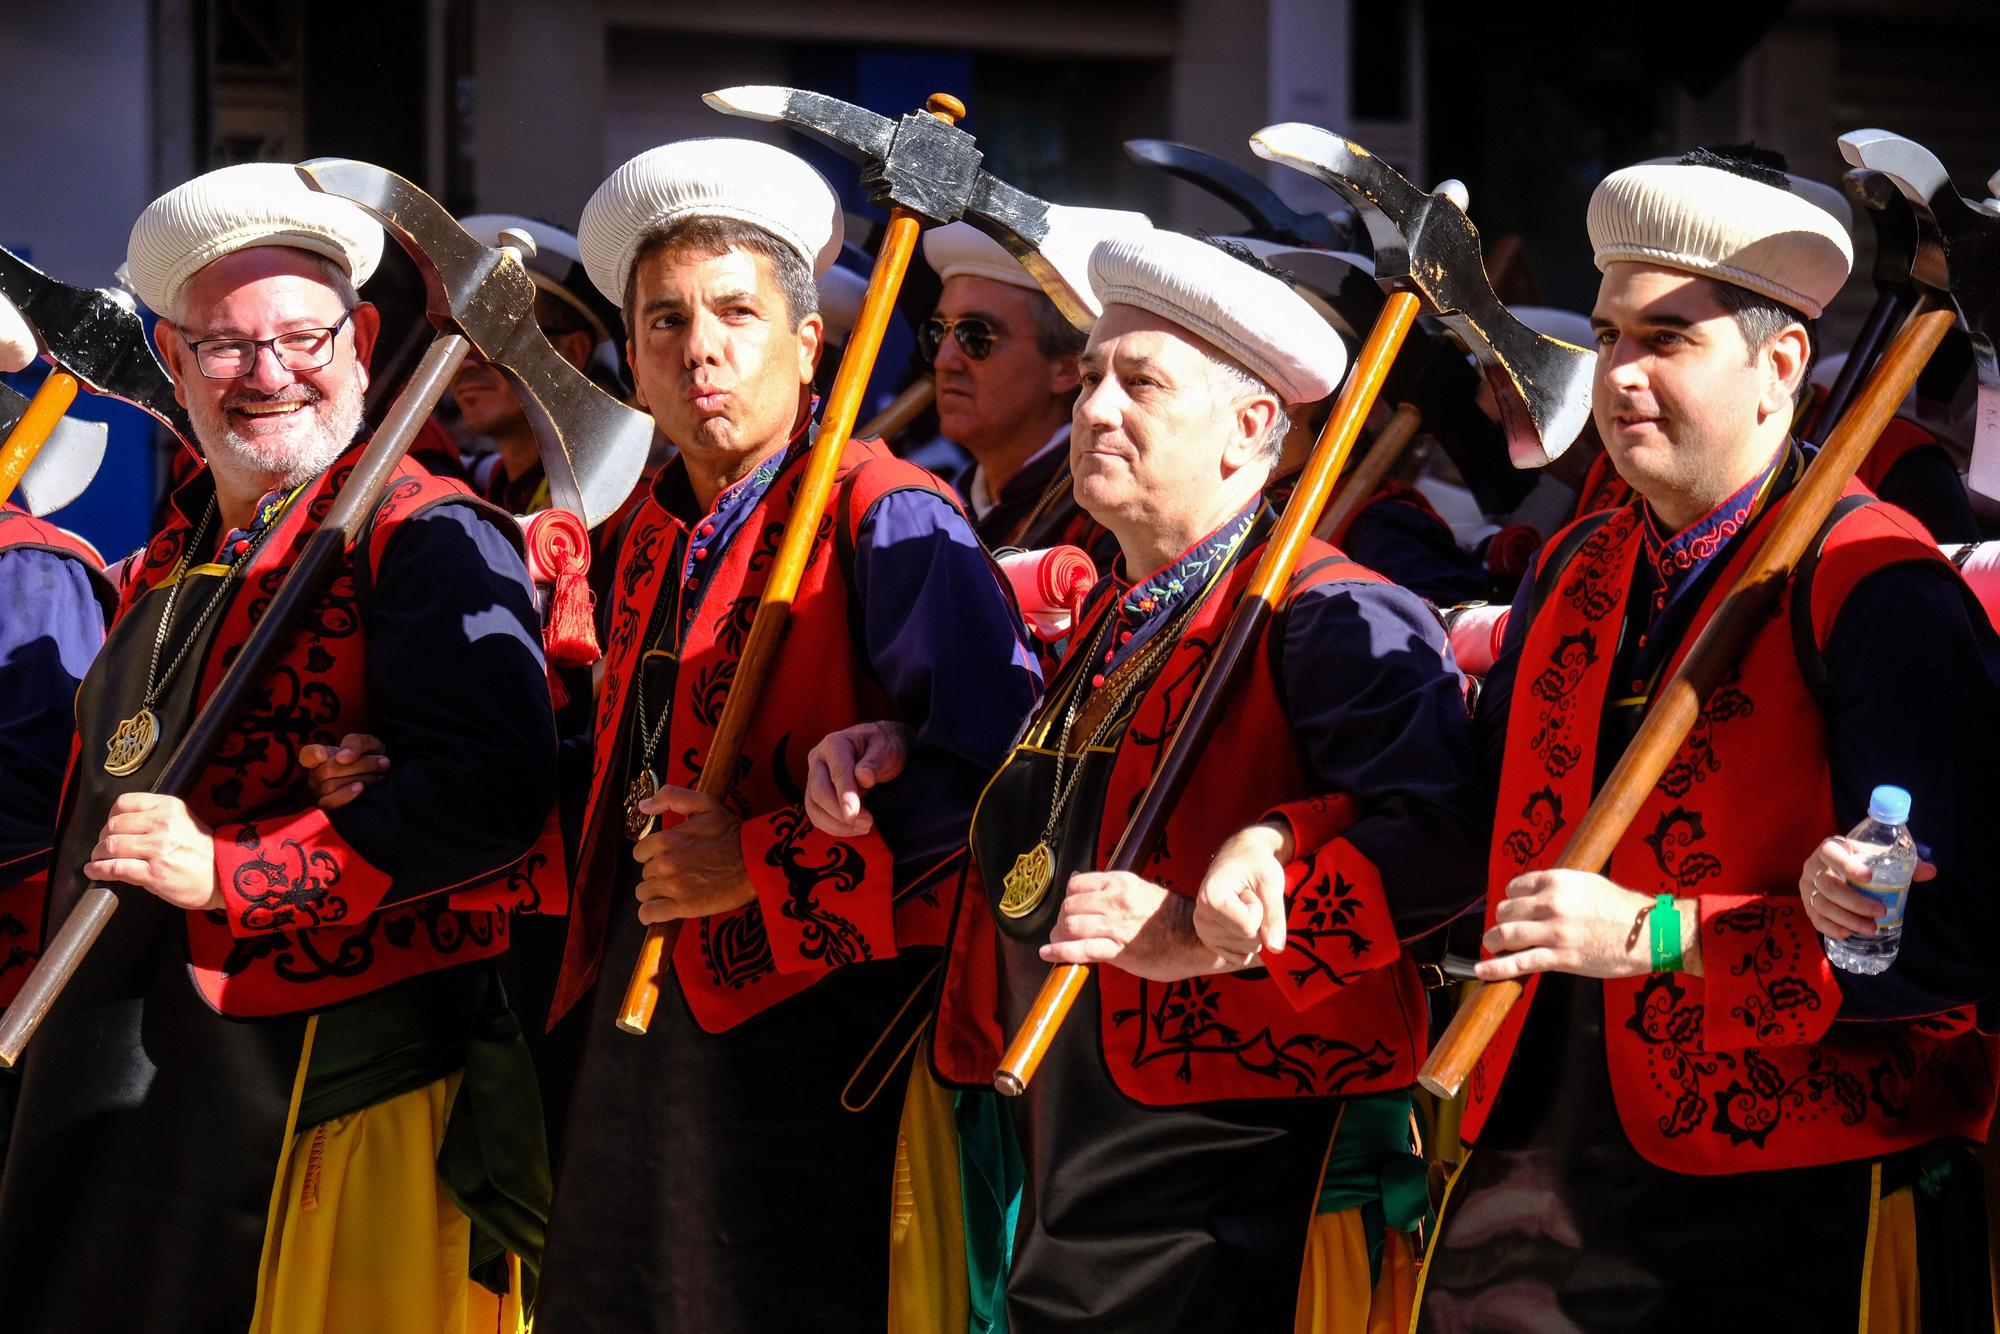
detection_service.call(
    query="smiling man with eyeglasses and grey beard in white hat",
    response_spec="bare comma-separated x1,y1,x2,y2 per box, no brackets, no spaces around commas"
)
0,164,556,1334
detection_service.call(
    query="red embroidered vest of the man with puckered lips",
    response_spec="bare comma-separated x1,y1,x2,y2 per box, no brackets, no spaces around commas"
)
550,440,954,1032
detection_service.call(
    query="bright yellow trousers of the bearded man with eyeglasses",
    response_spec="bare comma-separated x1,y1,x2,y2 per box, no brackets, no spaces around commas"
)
250,1074,526,1334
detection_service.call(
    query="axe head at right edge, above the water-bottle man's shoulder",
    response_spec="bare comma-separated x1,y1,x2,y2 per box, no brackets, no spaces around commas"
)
1840,130,2000,496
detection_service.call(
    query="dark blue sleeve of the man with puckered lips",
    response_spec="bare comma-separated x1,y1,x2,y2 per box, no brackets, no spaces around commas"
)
854,490,1040,882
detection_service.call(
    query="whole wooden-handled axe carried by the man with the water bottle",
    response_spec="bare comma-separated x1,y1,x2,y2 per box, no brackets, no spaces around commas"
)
1418,130,2000,1098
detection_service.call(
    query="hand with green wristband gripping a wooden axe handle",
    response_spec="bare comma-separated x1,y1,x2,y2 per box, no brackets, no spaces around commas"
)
1472,870,1702,982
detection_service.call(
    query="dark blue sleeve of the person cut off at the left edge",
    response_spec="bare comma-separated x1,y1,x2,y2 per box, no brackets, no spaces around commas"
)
0,546,104,886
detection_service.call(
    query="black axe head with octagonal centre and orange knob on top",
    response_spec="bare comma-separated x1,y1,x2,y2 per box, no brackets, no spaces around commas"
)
702,84,1096,328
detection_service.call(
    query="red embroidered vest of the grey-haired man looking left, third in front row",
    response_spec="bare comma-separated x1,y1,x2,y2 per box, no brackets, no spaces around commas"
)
932,542,1426,1106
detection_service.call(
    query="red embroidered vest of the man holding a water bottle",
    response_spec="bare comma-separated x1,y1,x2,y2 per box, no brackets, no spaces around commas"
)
1462,486,1996,1174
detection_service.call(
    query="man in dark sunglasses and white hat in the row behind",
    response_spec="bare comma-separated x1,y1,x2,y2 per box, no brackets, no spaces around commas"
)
918,208,1152,564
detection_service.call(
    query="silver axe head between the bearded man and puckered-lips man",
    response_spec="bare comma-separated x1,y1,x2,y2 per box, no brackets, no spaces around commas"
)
298,158,652,528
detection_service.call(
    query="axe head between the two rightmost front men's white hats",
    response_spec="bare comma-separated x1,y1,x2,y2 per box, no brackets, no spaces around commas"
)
1250,122,1596,468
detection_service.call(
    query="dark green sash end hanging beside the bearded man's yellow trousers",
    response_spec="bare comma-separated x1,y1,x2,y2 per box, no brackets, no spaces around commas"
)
438,980,556,1308
